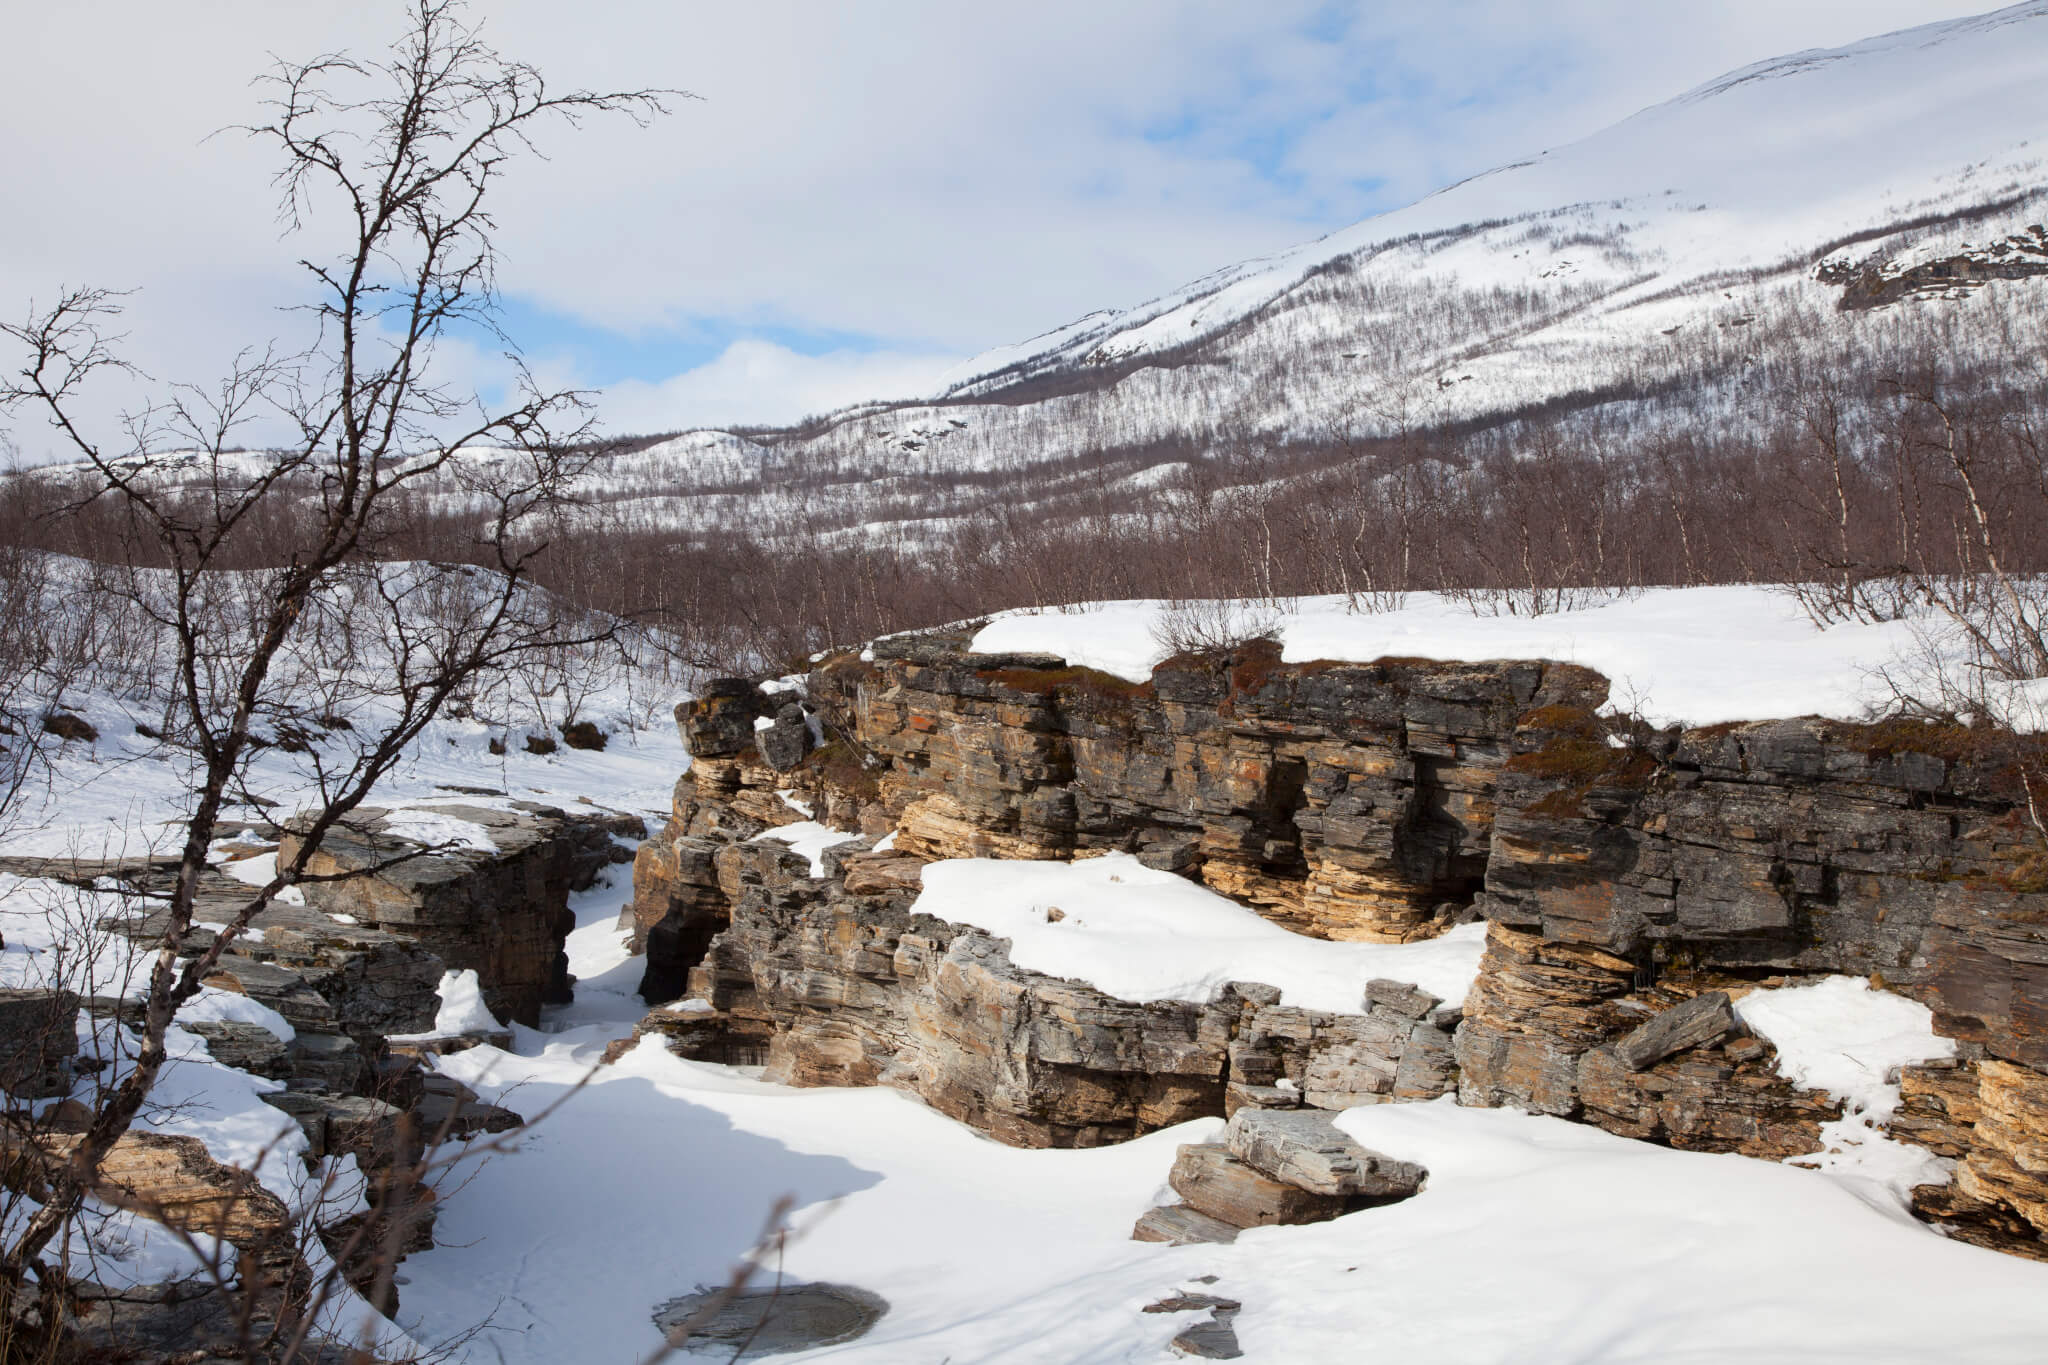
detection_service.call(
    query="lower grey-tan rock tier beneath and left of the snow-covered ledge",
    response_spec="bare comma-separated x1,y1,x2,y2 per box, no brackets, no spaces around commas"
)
614,826,1454,1146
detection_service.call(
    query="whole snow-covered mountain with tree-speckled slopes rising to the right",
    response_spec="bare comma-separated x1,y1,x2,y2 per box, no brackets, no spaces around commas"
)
573,0,2048,544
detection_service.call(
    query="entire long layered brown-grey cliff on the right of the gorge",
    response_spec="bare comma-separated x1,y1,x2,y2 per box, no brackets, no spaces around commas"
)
635,636,2048,1242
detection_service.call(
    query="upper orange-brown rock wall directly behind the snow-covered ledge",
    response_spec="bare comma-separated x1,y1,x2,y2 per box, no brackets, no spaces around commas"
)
811,636,1606,941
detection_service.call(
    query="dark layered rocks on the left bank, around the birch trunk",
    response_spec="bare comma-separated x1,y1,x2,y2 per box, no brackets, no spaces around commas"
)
0,802,643,1361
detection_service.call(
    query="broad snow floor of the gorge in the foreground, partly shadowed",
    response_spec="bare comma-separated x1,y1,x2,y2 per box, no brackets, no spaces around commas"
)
401,1029,2048,1365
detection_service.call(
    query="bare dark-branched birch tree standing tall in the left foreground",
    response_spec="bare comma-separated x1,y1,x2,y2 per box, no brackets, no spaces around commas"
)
0,0,670,1342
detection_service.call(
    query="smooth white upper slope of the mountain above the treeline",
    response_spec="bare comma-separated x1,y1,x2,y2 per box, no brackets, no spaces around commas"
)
948,0,2048,417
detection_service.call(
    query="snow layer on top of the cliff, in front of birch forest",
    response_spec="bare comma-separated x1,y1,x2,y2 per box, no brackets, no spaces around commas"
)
969,585,1966,724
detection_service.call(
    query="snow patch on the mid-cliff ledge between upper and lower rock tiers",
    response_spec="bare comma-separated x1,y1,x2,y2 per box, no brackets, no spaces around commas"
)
911,853,1485,1013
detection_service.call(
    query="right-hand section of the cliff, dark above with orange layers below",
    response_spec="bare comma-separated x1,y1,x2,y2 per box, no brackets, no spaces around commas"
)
1458,716,2048,1232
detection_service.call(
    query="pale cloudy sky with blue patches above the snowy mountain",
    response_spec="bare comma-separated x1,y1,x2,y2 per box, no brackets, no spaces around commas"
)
0,0,2015,460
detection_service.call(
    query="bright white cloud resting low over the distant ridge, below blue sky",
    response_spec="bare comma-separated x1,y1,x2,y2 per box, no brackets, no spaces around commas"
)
600,342,963,432
